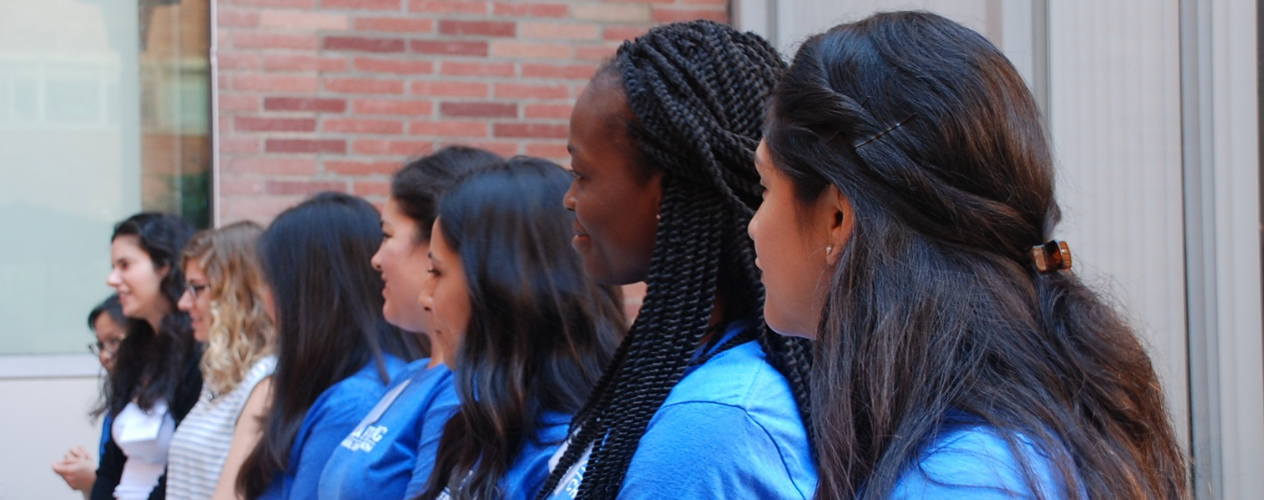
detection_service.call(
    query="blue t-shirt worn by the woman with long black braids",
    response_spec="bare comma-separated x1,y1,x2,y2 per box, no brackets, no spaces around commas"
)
538,324,817,500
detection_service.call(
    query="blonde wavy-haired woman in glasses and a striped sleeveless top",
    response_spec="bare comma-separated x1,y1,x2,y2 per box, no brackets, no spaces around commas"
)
167,221,277,500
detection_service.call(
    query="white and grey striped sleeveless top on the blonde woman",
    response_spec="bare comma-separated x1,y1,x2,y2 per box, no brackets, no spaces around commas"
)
167,356,277,500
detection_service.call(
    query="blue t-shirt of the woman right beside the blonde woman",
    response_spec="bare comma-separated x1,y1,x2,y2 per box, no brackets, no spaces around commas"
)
259,355,408,500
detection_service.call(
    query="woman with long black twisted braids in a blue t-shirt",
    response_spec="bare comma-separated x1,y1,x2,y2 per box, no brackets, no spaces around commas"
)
538,21,817,499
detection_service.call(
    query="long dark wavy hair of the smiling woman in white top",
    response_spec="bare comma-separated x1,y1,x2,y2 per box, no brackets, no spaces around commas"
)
101,212,201,415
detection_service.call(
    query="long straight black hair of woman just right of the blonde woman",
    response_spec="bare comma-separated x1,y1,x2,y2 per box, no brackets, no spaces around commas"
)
236,193,408,499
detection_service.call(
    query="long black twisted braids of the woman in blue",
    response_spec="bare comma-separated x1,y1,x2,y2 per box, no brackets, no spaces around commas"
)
537,21,811,499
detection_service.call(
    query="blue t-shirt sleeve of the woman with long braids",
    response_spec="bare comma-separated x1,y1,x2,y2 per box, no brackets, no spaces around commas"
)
618,402,813,500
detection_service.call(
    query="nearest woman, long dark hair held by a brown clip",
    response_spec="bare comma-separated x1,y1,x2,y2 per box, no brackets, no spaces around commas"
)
750,13,1188,500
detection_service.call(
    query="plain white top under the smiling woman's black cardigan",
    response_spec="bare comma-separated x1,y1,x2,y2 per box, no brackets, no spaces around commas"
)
110,399,176,500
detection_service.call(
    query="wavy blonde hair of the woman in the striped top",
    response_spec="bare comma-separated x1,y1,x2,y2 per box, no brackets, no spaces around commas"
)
181,221,277,395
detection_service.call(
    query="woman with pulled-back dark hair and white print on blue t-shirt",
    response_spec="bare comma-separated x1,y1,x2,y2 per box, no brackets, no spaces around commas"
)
319,146,504,500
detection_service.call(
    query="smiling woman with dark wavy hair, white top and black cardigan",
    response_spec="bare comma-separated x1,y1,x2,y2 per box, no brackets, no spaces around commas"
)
91,212,202,500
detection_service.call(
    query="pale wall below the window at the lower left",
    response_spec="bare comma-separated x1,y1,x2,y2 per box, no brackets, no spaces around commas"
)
0,373,101,500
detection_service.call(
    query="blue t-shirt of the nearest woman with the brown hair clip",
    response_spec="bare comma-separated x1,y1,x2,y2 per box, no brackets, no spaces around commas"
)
890,413,1067,500
